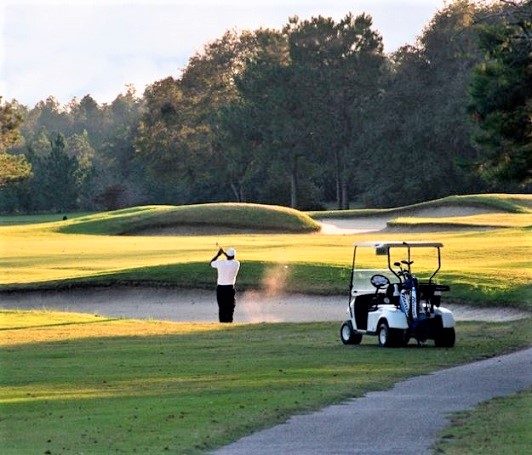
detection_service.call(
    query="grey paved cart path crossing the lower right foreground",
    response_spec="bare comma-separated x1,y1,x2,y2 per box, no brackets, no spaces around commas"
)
214,348,532,455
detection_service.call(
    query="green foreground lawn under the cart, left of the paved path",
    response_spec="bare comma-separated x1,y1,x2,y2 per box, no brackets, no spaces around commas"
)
0,312,531,454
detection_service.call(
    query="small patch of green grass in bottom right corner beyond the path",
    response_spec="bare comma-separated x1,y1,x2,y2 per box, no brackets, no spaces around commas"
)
434,389,532,455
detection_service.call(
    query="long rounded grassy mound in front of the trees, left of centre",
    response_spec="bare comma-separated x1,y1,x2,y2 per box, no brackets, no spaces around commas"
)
58,203,320,235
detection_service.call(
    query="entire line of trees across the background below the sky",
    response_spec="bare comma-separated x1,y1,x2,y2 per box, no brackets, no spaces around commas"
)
0,0,532,213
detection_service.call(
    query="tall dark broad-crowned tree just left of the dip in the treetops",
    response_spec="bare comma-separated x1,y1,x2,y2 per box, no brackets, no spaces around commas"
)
287,14,385,209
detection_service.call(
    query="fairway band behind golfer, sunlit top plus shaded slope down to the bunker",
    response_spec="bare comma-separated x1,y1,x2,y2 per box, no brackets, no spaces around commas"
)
0,224,532,309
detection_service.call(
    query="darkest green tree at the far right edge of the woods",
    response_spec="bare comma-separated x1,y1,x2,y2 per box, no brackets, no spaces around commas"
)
470,1,532,188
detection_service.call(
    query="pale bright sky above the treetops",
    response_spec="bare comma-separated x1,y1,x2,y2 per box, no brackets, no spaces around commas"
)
0,0,445,107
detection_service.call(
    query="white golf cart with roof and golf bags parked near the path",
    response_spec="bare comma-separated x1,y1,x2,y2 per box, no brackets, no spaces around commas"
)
340,241,455,348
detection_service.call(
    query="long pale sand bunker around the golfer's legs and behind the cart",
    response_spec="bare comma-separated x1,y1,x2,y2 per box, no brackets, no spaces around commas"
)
0,286,530,323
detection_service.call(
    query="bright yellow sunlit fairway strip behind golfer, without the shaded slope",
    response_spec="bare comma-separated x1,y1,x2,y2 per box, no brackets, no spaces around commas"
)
0,226,532,304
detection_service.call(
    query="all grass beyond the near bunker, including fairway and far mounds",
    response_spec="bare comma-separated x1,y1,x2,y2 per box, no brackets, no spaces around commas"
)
0,195,532,308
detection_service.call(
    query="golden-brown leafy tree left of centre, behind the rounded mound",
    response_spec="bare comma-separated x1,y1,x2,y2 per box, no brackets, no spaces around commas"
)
136,32,274,203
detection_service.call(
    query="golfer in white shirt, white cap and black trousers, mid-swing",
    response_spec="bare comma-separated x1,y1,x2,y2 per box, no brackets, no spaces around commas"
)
211,248,240,322
